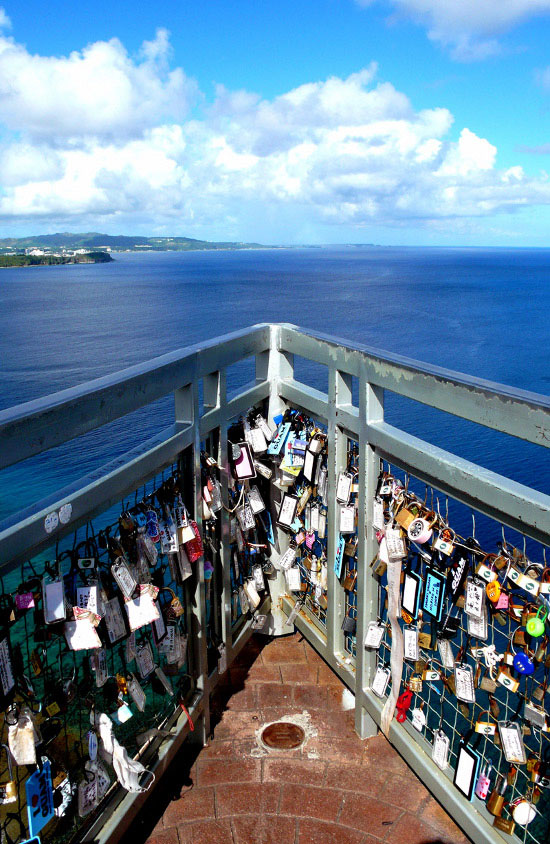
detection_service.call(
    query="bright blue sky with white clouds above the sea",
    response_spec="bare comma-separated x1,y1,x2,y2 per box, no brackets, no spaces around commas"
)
0,0,550,247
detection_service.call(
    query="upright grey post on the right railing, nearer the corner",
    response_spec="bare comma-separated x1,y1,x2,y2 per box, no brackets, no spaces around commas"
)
327,367,351,655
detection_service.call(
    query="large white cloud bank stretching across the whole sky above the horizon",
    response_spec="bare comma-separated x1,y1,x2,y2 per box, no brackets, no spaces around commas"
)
0,32,550,240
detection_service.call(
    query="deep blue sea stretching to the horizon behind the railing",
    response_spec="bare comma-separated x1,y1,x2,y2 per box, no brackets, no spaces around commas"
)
0,247,550,544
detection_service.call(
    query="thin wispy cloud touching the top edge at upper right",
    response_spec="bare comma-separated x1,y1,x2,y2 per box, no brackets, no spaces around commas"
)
357,0,550,61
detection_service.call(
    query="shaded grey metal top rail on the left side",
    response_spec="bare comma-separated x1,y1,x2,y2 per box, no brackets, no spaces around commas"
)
0,325,271,469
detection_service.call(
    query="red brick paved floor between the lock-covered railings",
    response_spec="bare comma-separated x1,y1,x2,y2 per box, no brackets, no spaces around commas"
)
135,634,474,844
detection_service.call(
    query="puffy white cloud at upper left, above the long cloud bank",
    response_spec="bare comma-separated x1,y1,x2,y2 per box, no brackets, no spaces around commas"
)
0,29,196,139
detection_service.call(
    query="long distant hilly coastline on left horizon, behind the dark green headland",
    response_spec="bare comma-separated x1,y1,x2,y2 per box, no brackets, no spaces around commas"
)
0,232,261,252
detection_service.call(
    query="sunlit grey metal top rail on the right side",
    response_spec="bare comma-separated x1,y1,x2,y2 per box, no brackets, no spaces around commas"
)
278,325,550,448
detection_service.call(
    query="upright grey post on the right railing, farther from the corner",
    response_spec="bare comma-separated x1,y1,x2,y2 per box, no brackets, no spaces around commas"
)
355,371,384,738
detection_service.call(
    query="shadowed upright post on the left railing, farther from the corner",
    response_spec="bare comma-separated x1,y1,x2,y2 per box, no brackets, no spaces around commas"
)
174,377,210,744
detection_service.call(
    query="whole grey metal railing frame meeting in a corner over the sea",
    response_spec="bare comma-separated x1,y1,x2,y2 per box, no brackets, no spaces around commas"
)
0,324,550,842
